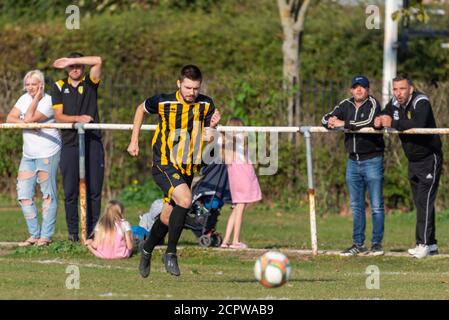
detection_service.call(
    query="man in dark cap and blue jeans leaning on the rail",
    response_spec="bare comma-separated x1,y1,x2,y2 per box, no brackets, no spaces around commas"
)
322,76,385,256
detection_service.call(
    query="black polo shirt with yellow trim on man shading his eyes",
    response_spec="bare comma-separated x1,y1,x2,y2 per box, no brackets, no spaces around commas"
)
51,74,101,146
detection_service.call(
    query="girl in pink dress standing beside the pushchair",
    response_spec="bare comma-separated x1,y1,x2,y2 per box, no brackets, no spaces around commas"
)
221,118,262,249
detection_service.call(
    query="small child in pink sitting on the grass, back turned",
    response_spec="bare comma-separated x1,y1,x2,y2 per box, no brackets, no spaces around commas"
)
86,200,133,259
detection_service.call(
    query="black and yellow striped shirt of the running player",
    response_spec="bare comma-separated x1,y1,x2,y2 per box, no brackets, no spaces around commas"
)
144,91,215,176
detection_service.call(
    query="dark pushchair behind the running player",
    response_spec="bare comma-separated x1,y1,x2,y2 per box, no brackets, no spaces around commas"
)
184,164,232,247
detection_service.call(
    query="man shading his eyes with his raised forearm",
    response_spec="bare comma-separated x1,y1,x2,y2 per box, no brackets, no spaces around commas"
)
52,52,104,241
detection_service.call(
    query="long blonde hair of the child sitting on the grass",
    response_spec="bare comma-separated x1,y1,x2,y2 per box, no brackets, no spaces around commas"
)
95,200,125,244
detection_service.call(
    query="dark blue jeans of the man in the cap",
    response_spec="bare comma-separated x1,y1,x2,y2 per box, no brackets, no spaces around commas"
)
346,156,384,245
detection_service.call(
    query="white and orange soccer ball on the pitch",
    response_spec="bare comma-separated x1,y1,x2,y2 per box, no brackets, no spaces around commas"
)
254,251,292,288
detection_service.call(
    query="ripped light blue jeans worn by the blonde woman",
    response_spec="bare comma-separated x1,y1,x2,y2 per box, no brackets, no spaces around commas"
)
17,151,60,239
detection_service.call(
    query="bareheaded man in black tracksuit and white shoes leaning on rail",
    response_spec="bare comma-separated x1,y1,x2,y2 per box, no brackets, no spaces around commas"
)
382,77,443,259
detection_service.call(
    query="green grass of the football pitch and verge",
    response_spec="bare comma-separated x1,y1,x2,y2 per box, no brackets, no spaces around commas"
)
0,205,449,300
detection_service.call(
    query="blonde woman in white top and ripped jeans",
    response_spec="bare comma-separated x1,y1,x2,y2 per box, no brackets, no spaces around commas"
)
6,70,61,246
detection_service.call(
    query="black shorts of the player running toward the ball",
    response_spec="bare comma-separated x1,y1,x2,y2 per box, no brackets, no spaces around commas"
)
151,164,193,205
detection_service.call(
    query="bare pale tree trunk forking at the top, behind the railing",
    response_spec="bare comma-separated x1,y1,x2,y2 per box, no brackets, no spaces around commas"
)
278,0,310,137
